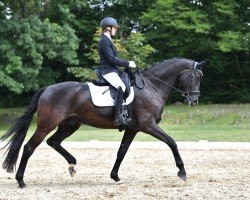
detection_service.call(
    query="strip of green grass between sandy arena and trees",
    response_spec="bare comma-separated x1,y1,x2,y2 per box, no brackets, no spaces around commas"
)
0,104,250,142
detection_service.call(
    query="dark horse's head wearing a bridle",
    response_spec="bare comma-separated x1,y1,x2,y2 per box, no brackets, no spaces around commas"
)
178,60,208,106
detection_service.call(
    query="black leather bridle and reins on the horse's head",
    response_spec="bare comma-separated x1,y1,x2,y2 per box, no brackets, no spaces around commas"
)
137,62,203,98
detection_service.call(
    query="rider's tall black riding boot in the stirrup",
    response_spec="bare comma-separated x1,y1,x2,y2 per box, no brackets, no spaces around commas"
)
115,87,131,126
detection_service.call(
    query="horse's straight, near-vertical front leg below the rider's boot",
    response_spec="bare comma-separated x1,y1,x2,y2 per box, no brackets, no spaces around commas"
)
110,130,137,183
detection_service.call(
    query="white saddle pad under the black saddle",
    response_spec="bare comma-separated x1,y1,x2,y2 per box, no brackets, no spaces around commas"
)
87,83,135,107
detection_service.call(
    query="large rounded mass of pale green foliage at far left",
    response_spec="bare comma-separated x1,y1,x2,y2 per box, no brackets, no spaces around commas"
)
0,16,78,94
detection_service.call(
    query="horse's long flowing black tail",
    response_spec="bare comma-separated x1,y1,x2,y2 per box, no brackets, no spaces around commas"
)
0,88,46,172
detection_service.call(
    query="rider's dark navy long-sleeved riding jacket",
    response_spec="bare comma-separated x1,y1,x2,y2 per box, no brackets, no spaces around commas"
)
98,34,129,75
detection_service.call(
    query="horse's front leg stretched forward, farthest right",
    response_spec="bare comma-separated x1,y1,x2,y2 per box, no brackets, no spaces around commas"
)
143,123,186,181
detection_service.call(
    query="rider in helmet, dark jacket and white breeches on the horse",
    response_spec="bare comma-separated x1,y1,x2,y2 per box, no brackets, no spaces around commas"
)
98,17,136,125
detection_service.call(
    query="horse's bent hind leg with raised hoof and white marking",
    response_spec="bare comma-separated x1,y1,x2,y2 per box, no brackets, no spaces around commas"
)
47,120,81,177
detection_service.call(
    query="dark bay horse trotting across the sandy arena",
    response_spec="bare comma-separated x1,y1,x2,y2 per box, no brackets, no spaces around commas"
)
0,58,207,188
